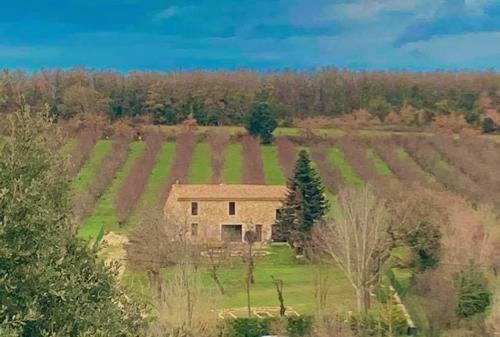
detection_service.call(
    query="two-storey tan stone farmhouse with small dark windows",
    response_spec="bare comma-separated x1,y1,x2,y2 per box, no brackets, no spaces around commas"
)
164,184,287,243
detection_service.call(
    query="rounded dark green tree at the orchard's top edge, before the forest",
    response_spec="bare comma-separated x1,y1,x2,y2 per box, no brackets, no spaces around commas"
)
245,102,278,144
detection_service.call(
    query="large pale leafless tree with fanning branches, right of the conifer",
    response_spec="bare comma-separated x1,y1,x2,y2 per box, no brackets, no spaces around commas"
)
313,187,391,314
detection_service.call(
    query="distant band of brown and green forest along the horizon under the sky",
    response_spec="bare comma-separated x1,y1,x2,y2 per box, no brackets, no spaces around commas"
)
0,68,500,126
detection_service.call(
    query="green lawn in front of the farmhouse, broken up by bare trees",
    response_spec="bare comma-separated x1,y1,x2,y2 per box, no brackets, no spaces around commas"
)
122,245,355,314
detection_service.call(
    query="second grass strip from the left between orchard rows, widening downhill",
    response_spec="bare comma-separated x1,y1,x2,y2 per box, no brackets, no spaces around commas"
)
78,142,145,239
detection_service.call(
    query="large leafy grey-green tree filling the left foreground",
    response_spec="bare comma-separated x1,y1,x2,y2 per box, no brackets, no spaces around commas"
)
0,106,142,337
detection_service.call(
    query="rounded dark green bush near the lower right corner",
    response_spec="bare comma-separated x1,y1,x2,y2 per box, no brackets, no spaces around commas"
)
455,267,491,318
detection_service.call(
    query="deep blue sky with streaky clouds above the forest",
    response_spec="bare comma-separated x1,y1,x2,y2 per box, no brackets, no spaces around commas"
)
0,0,500,72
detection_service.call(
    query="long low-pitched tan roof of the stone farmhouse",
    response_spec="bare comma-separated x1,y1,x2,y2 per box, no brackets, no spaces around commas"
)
171,184,287,201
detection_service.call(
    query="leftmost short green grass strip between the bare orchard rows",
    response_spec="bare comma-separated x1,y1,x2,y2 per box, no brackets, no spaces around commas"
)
72,140,112,193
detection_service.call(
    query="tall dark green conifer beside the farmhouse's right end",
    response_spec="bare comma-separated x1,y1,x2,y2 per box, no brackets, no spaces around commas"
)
276,150,329,244
